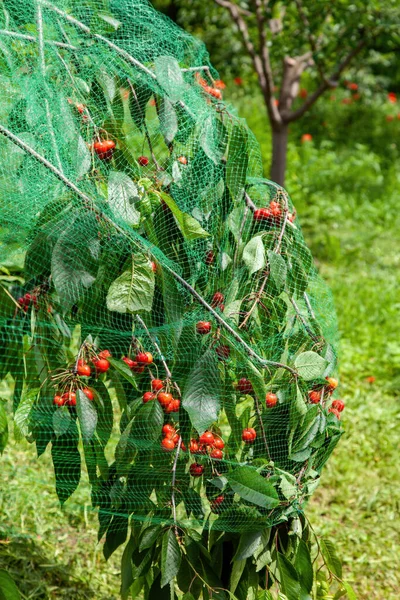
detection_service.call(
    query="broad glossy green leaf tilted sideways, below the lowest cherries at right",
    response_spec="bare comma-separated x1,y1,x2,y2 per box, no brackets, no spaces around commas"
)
227,466,279,508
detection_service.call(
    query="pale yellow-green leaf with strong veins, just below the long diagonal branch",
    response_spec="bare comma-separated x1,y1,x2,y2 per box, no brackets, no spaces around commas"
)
107,254,155,313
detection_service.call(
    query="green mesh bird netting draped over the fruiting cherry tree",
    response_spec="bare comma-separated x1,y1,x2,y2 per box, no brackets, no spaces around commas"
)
0,0,343,554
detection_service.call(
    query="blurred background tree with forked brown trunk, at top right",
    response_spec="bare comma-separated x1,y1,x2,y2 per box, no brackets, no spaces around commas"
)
156,0,399,185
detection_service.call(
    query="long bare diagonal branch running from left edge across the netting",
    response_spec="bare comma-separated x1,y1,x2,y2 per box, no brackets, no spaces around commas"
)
0,125,297,377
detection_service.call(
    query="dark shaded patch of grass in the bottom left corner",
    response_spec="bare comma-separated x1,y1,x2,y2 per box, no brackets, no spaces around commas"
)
0,531,109,600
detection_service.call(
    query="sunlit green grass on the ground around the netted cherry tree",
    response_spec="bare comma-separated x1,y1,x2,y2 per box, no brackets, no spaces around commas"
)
0,96,400,600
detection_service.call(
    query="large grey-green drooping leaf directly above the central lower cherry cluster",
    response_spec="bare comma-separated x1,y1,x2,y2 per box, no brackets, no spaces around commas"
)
182,348,221,434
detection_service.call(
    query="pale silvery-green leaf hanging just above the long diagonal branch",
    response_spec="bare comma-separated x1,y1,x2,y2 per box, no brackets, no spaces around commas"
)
108,171,140,225
